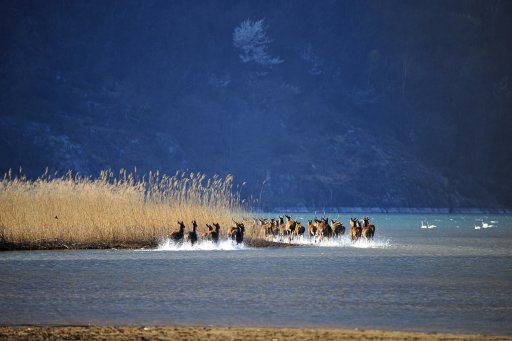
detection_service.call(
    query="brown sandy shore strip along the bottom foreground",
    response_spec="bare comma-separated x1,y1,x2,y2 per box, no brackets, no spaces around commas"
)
0,325,512,341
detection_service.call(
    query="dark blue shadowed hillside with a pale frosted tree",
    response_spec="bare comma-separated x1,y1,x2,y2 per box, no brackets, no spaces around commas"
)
0,0,512,209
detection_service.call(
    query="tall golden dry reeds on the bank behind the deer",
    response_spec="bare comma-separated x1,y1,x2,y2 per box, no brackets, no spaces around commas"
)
0,170,254,243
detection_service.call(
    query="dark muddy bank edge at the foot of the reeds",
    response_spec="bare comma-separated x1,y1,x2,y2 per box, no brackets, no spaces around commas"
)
0,238,299,252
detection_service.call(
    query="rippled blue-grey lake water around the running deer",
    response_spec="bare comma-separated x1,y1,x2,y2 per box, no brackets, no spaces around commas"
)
0,214,512,335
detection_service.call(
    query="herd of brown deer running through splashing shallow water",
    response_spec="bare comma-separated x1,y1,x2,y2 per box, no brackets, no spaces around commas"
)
170,215,375,245
